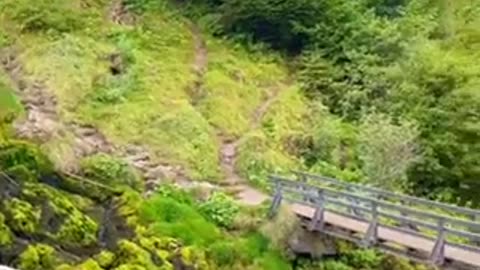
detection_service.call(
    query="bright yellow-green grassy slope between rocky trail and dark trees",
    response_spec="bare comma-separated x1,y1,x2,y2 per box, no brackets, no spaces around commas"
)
3,1,304,184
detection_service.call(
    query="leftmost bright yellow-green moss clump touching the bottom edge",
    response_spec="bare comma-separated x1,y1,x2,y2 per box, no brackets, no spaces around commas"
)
19,244,57,270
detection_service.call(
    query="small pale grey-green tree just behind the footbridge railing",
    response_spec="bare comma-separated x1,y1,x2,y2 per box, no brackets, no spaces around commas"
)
359,114,419,189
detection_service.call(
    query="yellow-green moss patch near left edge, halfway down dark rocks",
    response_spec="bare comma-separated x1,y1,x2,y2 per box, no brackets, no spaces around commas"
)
4,198,40,234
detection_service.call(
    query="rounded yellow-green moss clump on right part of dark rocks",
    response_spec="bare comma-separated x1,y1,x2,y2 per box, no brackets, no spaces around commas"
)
56,211,98,246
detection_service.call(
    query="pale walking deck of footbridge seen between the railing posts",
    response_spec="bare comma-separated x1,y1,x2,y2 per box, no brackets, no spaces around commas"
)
291,203,480,267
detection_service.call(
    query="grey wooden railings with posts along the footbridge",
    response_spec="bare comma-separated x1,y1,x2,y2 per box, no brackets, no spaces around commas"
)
270,174,480,264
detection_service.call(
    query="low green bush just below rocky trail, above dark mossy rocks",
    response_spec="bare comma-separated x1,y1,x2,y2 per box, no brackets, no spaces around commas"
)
81,154,141,190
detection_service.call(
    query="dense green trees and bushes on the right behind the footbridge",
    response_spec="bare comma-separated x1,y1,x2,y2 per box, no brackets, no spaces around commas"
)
190,0,480,204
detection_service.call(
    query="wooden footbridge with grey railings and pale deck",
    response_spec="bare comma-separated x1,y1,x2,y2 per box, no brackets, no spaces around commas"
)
270,172,480,269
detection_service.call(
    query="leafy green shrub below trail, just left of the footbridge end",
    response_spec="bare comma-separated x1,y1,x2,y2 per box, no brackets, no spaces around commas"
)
200,192,240,228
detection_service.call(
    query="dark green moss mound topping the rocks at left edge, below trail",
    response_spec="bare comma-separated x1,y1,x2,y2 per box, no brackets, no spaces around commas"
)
0,140,53,176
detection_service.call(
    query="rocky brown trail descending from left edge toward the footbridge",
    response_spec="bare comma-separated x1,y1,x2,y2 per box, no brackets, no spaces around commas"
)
0,49,204,193
